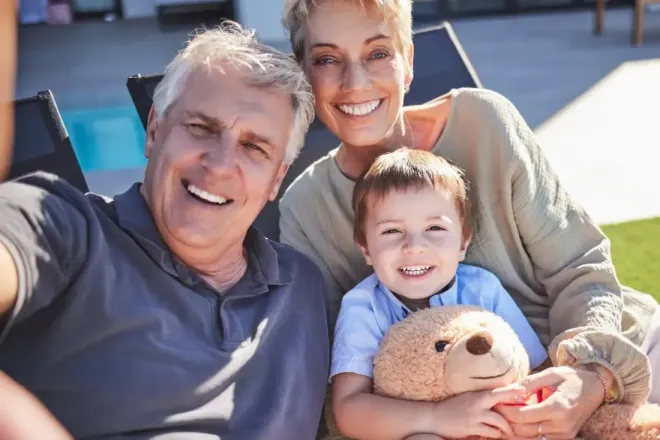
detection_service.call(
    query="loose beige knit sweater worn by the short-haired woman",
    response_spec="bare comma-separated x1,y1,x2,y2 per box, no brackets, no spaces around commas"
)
280,89,657,402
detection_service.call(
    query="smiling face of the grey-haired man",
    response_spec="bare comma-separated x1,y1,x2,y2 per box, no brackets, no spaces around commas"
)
143,68,294,261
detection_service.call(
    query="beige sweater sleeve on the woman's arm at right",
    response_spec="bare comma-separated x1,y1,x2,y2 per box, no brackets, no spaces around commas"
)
498,94,650,403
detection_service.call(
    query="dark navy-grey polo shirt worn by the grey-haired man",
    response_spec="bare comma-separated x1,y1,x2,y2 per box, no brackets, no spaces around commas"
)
0,174,330,440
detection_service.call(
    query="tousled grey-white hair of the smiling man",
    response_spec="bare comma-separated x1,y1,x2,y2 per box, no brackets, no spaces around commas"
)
153,21,314,164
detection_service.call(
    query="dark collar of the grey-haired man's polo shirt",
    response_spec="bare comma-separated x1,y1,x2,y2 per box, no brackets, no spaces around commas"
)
114,183,292,291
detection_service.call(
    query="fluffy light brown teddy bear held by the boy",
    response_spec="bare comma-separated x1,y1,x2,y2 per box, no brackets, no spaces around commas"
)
373,305,660,440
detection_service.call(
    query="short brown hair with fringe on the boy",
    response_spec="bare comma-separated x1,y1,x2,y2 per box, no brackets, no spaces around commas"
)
353,147,472,246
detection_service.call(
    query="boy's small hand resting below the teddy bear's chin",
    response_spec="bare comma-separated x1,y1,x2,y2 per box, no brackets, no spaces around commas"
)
436,384,526,438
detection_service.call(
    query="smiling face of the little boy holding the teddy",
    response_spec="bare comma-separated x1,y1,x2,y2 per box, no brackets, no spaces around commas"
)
362,188,469,299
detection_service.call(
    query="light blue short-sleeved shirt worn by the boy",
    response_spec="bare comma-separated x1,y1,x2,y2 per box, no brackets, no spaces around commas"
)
330,264,548,378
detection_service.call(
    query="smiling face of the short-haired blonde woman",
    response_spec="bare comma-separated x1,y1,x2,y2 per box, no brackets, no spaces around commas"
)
305,1,412,146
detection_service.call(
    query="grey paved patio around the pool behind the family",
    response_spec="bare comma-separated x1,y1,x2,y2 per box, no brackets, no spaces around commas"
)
18,9,660,223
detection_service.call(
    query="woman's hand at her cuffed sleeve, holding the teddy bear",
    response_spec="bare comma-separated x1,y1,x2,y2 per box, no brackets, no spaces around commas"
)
496,367,605,440
